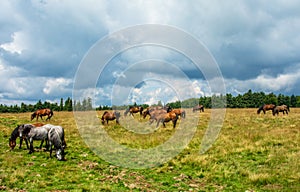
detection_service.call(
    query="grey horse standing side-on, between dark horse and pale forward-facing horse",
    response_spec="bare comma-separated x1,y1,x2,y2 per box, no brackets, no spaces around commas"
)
19,124,49,154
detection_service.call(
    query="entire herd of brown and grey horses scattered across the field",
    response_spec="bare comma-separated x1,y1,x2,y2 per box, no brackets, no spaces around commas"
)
9,104,290,160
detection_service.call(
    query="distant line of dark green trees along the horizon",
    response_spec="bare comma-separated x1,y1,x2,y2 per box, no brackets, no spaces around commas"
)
0,90,300,113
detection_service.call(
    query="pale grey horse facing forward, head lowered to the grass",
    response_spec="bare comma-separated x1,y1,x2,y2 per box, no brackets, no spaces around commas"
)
47,124,66,161
